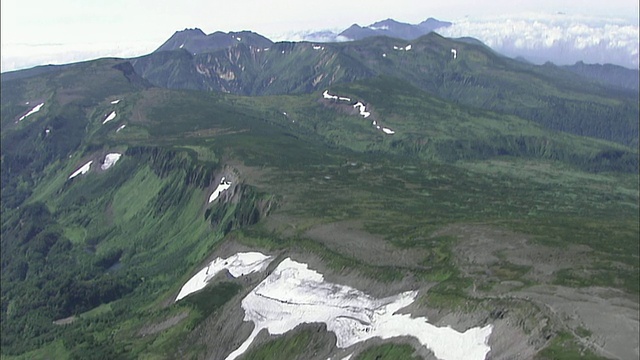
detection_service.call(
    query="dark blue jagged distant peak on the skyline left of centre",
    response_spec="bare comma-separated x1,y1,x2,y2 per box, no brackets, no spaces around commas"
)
156,28,273,54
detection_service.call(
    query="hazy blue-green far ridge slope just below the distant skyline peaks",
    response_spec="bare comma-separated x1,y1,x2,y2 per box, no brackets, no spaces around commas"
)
132,33,638,146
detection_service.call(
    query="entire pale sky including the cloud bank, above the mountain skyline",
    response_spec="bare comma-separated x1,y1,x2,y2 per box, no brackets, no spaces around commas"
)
0,0,639,72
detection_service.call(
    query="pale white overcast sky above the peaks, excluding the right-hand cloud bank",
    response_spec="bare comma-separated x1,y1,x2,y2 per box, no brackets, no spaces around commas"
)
0,0,639,71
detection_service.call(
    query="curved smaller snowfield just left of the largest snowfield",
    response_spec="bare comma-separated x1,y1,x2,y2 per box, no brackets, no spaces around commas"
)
175,252,272,301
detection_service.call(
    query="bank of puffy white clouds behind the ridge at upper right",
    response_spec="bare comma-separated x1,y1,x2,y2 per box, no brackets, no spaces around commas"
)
438,14,640,69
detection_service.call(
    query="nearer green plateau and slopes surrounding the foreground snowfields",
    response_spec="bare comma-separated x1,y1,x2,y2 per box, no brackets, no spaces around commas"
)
0,56,639,359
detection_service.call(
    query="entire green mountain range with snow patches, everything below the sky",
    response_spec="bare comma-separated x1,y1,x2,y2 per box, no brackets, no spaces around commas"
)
0,19,640,360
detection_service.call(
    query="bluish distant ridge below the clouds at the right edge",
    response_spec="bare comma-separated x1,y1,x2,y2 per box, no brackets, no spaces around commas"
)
562,61,640,92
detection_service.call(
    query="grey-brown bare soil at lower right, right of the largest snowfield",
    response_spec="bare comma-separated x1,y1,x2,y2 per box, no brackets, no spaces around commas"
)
438,224,640,359
